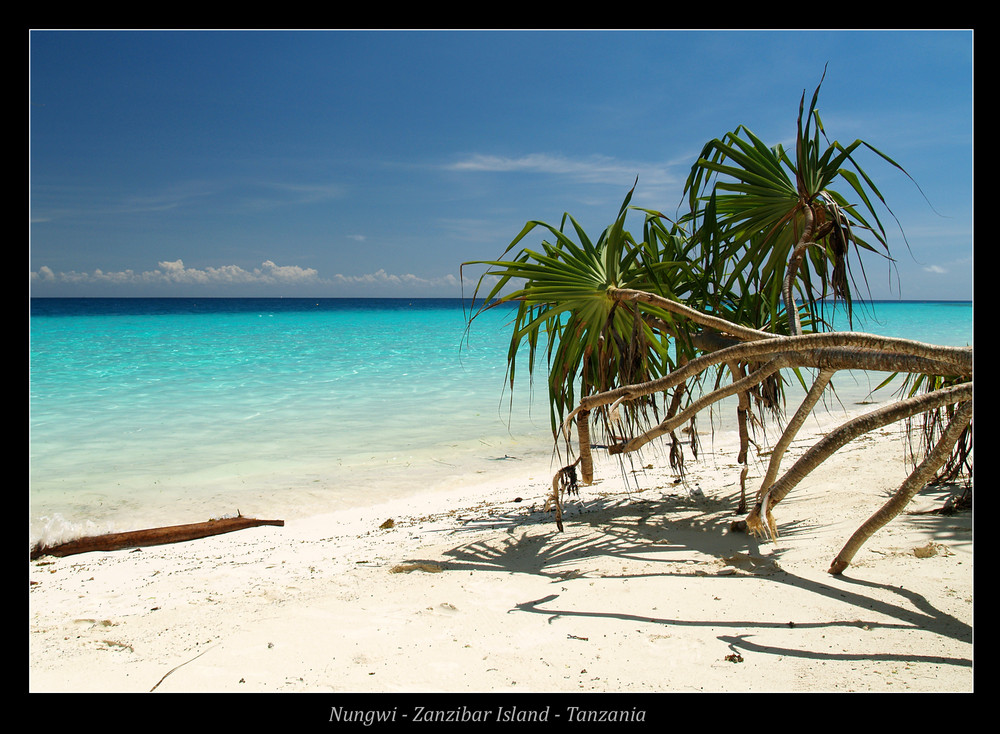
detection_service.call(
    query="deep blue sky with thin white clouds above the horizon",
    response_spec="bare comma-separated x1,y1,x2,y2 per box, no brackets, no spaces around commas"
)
29,31,973,300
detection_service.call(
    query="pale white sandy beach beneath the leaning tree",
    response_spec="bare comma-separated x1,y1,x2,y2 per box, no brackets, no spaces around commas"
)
29,406,973,705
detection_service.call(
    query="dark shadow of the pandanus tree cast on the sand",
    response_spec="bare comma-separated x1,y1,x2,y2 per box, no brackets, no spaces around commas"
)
396,488,972,667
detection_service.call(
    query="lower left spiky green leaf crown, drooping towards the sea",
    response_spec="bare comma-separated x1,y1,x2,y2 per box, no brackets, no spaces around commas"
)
463,185,689,431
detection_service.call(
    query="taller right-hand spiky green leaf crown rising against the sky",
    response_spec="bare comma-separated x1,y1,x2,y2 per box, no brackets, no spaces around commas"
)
685,70,905,332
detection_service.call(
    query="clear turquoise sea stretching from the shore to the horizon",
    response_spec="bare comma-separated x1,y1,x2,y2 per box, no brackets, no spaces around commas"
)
29,298,972,540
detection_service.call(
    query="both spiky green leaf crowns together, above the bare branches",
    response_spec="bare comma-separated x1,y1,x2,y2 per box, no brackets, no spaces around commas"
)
463,70,905,448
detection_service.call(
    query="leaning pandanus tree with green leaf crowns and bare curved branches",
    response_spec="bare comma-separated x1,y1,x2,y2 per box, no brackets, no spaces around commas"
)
463,76,972,573
